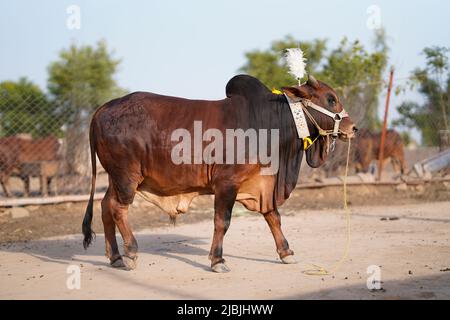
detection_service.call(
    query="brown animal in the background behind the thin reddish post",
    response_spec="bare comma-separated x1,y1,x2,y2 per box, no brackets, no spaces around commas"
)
354,129,408,174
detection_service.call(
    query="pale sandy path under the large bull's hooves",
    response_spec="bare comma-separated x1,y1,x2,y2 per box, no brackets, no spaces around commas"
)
0,202,450,299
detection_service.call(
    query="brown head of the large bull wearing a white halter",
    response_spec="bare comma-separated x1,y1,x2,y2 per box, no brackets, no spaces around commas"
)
283,76,357,168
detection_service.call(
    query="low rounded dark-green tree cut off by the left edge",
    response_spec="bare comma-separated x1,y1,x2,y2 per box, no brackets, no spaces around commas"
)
0,78,63,137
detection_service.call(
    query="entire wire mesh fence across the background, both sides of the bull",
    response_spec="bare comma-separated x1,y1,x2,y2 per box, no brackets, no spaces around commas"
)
0,84,450,198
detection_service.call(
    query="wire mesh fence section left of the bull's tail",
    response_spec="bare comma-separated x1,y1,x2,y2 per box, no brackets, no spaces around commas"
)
0,94,106,198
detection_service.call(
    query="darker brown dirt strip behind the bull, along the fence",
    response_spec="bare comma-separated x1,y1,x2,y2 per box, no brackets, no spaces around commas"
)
0,182,450,243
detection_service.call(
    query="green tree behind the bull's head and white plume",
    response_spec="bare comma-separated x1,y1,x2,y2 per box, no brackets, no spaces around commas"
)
240,30,388,129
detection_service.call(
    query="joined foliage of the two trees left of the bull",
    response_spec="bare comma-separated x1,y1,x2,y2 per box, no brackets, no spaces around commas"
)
0,42,125,137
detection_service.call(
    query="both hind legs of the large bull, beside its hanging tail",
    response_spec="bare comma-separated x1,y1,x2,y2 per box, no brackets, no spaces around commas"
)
102,183,138,270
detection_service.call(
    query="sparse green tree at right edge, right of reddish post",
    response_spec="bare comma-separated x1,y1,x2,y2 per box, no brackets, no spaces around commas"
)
394,47,450,146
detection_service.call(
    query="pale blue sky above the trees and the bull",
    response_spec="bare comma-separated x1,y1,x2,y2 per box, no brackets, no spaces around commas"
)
0,0,450,135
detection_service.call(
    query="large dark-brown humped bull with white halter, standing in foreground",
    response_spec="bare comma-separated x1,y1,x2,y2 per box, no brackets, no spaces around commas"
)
82,76,355,272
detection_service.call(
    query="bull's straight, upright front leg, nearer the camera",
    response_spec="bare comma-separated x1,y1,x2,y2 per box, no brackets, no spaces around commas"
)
209,187,237,273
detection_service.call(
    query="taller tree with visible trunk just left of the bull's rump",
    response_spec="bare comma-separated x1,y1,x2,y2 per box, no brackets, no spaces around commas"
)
48,41,125,175
